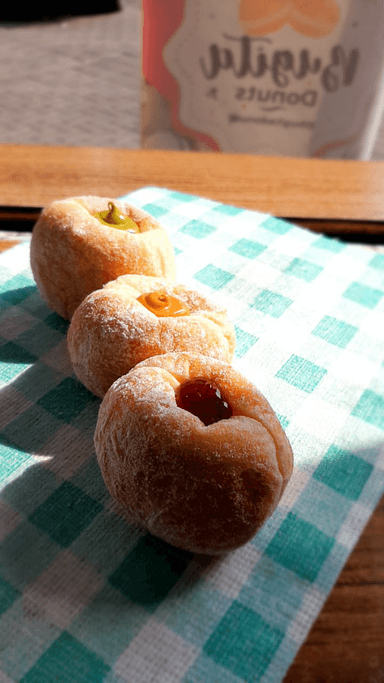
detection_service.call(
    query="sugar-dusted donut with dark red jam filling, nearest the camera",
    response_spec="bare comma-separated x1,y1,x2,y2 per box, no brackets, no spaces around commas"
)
95,353,293,554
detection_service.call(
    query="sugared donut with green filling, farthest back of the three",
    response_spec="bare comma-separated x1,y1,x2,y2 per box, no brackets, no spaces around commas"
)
31,196,176,320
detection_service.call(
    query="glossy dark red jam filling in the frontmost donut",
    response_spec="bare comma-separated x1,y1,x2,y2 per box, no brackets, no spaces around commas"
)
176,378,232,427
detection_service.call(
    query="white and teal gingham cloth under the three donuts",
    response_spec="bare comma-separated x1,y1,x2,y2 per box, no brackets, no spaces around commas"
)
0,188,384,683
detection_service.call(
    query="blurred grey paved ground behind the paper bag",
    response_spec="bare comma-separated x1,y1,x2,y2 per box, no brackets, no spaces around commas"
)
0,0,384,160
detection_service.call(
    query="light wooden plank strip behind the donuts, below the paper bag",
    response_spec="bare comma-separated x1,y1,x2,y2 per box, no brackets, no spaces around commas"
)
0,144,384,234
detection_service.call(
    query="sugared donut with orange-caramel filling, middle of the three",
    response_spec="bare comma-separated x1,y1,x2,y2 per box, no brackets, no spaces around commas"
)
68,275,235,397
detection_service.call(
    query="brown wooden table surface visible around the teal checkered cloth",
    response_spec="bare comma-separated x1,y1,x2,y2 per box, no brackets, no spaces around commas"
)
0,145,384,683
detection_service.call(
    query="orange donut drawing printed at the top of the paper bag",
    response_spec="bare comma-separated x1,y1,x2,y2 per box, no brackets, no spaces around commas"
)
239,0,340,38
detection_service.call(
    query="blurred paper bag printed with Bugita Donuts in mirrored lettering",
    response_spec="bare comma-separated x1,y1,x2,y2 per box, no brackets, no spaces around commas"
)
142,0,384,159
